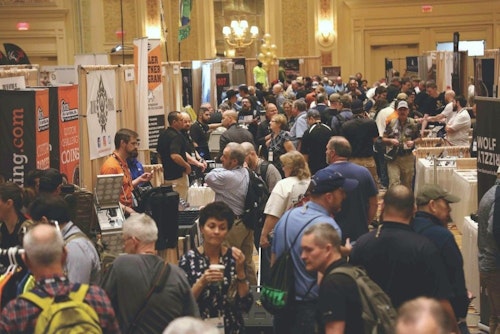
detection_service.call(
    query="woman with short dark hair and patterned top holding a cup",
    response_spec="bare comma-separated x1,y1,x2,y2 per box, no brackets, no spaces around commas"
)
179,202,253,333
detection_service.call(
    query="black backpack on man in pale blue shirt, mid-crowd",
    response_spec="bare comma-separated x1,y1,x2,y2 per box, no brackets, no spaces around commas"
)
241,167,269,230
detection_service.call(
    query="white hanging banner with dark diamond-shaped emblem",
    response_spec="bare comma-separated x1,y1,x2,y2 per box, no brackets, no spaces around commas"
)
87,70,117,159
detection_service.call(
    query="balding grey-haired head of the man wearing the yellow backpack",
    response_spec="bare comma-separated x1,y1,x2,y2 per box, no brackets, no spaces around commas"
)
23,224,64,266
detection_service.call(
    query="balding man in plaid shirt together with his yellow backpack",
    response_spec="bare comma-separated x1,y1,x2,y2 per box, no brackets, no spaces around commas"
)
0,224,120,333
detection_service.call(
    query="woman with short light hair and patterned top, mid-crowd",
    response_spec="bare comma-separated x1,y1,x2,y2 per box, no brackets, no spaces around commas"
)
266,114,295,177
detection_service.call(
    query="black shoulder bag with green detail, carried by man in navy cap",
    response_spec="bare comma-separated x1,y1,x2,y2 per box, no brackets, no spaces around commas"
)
260,210,320,315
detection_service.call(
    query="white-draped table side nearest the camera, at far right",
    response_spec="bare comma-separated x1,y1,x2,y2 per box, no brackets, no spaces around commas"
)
462,216,481,313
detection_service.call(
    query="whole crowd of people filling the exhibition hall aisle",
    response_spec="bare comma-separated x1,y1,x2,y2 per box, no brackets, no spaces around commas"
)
0,73,488,333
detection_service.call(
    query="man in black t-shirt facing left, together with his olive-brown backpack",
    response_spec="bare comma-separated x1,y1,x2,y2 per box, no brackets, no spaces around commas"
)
301,223,397,334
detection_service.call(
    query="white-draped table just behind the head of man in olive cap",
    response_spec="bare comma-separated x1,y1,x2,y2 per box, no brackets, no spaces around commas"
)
415,158,458,194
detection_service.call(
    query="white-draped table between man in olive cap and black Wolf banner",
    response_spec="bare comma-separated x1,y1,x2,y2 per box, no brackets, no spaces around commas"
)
449,169,477,233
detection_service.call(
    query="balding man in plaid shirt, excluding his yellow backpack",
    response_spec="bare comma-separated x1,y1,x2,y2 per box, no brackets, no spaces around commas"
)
0,224,120,333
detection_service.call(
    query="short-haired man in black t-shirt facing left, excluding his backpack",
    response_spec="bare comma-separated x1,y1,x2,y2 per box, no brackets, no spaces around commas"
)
301,223,363,334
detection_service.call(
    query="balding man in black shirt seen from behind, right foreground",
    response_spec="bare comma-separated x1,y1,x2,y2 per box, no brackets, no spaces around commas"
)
349,185,460,333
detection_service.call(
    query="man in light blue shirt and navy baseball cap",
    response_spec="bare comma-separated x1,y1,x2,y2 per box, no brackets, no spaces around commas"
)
271,168,358,334
